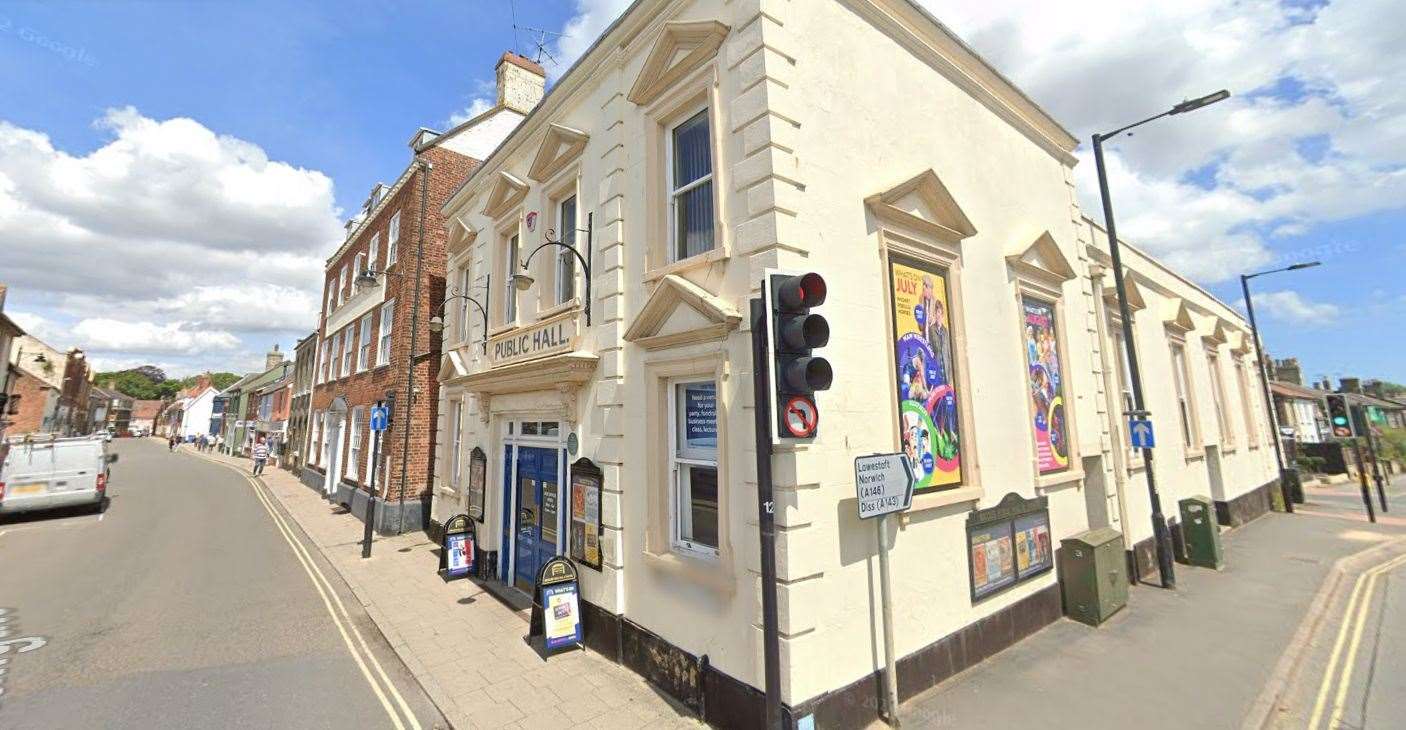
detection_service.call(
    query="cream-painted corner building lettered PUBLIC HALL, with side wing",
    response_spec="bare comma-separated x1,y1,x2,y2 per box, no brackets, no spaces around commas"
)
434,0,1277,727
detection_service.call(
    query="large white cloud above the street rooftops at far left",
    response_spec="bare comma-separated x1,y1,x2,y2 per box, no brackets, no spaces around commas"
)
0,107,343,370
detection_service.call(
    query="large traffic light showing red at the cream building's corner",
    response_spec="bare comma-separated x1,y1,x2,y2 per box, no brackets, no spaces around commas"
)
765,271,834,439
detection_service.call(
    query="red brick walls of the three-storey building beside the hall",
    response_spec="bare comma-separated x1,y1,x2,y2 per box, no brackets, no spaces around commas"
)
309,148,478,501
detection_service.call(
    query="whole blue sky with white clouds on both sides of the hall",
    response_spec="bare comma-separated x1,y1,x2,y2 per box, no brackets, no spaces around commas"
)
0,0,1406,383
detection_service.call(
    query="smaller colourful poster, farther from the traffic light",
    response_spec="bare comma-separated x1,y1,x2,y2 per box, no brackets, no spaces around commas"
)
1021,298,1069,474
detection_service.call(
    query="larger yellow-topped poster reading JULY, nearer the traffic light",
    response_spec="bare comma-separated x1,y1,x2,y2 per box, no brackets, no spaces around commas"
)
889,257,962,491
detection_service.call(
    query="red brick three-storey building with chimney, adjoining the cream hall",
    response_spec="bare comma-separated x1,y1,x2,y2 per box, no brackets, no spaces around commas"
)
304,53,546,533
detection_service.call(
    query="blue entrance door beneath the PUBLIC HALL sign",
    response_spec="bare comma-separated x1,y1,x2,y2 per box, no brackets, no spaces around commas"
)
513,446,560,591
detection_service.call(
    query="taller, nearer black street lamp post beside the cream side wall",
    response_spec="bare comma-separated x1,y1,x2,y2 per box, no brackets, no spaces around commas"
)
1094,90,1230,588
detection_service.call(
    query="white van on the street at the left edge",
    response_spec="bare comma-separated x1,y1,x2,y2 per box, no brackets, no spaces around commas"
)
0,435,117,515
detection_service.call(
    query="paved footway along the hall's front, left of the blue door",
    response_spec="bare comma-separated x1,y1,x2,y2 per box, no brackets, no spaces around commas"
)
188,441,702,730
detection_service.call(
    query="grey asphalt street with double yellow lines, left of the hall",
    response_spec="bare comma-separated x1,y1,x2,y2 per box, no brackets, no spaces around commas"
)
0,439,444,730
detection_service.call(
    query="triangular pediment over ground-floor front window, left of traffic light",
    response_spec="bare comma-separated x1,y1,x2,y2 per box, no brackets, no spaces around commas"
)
624,274,742,350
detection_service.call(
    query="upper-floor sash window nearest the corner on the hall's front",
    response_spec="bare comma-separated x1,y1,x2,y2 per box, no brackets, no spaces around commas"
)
668,108,713,262
